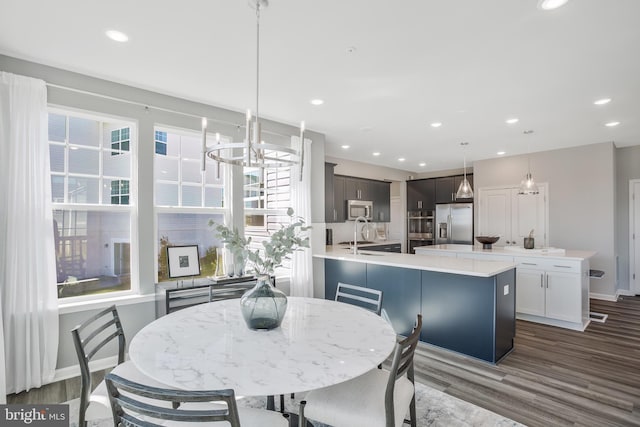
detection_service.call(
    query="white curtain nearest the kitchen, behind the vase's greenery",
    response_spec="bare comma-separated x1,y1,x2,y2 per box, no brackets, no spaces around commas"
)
289,137,312,297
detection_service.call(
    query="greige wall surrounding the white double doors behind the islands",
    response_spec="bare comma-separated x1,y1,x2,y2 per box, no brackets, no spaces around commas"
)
473,143,616,298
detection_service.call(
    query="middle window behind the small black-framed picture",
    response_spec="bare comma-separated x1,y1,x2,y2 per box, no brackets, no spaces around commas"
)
154,129,228,282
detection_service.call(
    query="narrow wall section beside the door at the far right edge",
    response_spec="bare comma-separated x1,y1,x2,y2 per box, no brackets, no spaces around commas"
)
616,145,640,293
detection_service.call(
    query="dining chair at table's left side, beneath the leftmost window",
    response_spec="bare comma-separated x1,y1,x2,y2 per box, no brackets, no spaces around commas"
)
71,305,176,427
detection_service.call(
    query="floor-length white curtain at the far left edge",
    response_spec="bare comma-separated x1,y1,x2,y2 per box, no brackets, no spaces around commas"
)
0,72,58,393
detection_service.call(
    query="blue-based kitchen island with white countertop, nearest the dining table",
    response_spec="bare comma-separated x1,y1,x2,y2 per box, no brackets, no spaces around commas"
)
314,247,515,363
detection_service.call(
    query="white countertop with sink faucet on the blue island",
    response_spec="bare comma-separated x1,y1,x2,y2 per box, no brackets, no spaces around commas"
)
313,245,515,277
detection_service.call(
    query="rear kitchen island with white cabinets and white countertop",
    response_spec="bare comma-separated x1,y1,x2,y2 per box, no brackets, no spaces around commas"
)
415,245,596,331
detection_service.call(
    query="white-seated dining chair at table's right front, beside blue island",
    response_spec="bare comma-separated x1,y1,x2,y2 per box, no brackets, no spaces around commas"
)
299,315,422,427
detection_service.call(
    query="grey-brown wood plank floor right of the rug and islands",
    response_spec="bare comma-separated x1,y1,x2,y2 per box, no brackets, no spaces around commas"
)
415,296,640,427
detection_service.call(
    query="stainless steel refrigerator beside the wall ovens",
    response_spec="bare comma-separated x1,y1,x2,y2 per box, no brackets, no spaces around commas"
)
436,203,473,245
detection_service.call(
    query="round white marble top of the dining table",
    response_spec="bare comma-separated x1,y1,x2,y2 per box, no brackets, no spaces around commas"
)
129,297,396,396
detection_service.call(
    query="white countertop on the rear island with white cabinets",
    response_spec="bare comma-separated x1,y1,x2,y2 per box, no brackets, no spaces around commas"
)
414,244,596,261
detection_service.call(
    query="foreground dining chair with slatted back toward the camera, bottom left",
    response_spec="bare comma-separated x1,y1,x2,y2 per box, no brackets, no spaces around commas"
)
105,373,289,427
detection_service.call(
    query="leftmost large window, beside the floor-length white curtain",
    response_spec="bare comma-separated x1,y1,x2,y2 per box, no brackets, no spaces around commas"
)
49,110,134,298
